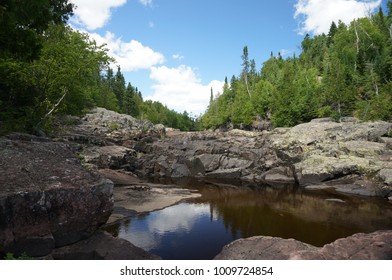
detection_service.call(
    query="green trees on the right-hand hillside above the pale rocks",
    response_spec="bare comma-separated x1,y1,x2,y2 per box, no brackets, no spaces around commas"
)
200,1,392,128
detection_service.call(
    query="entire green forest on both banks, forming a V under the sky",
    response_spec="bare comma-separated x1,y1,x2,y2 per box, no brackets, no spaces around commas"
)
0,0,392,134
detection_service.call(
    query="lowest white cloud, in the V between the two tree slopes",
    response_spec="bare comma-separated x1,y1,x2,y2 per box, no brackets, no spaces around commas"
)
149,65,224,115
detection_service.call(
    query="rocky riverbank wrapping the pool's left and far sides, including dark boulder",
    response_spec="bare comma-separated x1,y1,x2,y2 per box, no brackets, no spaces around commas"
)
0,108,392,258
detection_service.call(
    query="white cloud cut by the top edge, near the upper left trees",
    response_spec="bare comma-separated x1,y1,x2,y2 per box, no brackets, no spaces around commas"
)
71,0,127,30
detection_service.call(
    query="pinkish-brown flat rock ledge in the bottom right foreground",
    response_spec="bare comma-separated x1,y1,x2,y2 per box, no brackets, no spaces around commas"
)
215,231,392,260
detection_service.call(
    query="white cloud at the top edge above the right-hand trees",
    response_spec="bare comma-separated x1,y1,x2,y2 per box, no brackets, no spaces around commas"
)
294,0,381,35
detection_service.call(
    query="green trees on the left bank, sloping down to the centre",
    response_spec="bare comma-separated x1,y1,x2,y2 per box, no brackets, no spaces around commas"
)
0,0,195,134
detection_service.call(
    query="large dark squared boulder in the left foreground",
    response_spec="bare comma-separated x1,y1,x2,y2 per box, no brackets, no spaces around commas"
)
0,135,113,256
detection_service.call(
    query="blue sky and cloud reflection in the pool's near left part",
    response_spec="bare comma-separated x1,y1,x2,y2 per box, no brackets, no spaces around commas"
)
118,203,233,259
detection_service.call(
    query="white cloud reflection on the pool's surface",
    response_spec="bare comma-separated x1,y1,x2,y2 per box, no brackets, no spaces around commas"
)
148,203,210,234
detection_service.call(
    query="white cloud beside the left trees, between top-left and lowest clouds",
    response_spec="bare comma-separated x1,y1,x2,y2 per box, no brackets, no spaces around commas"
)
90,32,165,72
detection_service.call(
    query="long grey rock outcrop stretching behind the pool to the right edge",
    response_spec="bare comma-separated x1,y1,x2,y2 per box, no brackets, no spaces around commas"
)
57,108,392,198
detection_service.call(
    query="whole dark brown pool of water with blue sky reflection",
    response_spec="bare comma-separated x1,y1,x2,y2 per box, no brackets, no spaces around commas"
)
105,179,392,260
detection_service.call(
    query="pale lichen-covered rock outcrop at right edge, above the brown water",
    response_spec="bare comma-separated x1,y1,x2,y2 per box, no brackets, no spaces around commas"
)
270,118,392,197
